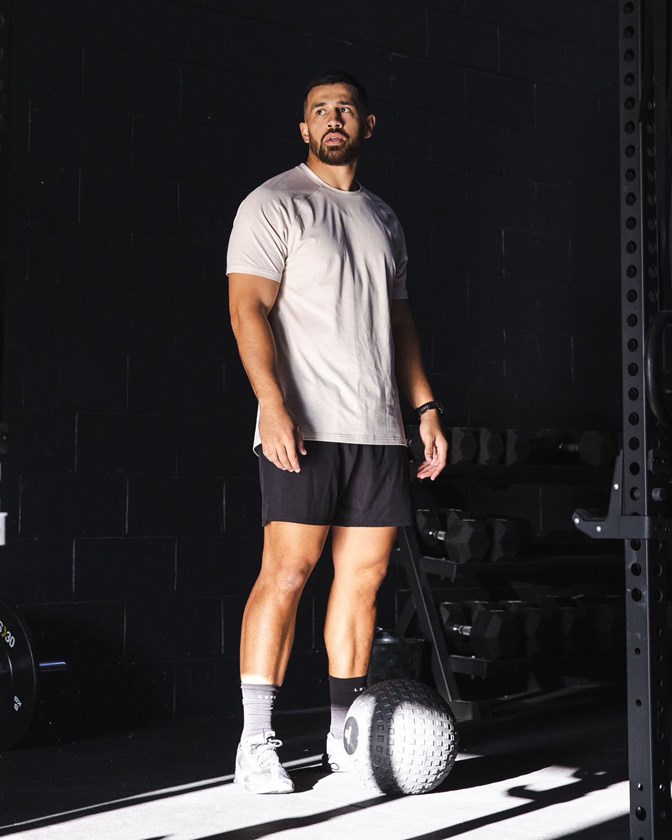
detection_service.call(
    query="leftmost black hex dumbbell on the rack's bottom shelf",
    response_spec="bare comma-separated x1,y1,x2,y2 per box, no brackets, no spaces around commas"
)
440,601,524,660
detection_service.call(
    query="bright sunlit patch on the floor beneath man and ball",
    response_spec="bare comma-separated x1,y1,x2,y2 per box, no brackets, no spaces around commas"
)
1,755,628,840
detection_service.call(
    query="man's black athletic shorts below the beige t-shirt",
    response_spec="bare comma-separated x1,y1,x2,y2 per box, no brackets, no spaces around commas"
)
259,440,411,528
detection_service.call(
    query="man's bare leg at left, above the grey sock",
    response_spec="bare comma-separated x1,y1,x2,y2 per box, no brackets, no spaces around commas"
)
240,522,329,685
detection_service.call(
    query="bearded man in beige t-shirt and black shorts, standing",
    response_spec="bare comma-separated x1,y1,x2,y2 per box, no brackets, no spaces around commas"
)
227,71,447,793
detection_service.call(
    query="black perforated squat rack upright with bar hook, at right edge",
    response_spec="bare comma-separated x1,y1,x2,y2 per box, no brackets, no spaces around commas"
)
574,0,672,840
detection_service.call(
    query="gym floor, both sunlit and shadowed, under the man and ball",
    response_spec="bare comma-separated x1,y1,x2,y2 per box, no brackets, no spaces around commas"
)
0,687,629,840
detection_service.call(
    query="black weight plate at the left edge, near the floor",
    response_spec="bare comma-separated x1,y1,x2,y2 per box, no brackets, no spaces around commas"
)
0,601,37,750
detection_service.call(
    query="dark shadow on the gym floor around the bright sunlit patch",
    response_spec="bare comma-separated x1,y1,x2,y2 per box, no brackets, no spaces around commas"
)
0,691,628,840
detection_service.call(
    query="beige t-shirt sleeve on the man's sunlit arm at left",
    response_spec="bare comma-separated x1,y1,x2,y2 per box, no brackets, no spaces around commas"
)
226,187,288,282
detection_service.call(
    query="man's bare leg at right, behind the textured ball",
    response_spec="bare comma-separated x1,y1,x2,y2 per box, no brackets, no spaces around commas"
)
324,526,397,678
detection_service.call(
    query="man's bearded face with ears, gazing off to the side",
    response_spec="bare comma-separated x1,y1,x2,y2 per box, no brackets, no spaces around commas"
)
300,83,376,166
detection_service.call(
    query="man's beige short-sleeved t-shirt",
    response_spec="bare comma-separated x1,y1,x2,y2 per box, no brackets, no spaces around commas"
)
227,164,407,450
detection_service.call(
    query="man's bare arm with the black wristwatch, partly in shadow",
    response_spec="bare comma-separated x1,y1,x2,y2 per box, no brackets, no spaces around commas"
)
392,299,448,481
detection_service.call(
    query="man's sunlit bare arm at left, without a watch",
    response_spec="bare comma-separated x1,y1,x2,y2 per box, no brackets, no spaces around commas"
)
229,274,306,472
